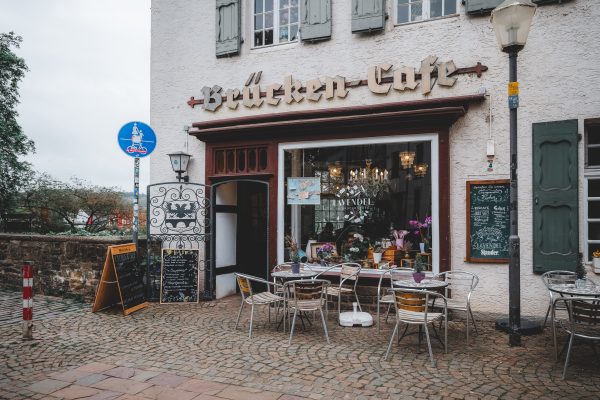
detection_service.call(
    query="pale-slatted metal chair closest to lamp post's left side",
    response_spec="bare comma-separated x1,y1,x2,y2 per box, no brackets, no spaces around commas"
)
434,270,479,345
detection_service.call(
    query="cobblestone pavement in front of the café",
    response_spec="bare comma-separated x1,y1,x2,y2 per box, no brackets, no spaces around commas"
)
0,291,600,400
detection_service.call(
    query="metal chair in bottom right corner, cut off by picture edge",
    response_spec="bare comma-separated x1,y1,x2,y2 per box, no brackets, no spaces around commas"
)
553,297,600,380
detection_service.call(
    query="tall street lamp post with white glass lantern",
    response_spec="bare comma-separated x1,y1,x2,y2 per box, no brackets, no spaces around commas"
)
492,0,536,346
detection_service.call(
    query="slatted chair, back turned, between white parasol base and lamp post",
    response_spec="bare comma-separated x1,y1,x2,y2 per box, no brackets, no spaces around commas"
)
384,288,448,367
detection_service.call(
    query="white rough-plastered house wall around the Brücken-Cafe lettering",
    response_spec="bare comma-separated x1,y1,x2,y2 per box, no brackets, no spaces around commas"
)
151,0,600,315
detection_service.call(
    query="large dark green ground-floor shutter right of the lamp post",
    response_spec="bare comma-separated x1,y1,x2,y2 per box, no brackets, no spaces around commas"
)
532,119,579,272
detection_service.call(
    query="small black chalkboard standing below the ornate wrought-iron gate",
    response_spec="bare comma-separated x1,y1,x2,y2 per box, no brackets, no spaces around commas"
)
160,249,199,304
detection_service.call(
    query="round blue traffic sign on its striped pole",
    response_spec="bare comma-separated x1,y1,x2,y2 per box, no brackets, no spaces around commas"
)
117,121,156,245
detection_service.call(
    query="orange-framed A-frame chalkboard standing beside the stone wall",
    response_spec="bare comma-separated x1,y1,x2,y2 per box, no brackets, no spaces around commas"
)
92,244,148,315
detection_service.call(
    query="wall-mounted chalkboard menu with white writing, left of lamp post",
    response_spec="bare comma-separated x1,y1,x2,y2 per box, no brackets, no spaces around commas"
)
466,179,510,263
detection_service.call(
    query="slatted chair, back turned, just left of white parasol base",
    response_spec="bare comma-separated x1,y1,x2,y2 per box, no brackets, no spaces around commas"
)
284,279,331,344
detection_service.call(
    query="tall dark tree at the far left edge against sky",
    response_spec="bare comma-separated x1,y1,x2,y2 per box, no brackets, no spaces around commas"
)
0,32,35,216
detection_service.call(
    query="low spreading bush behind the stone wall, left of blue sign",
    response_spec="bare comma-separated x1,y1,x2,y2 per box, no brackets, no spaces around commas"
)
23,174,130,232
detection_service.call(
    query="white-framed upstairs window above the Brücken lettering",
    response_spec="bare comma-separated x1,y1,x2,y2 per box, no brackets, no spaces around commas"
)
254,0,299,47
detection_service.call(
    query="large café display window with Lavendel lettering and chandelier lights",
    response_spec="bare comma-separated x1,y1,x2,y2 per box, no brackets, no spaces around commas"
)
279,135,437,271
